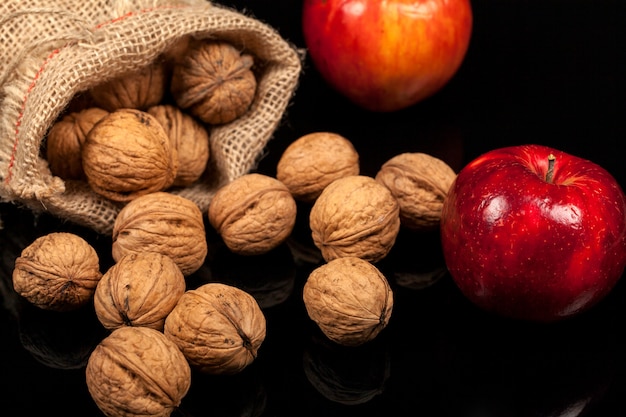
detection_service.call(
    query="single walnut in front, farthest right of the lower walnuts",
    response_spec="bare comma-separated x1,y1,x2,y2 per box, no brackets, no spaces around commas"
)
303,256,393,346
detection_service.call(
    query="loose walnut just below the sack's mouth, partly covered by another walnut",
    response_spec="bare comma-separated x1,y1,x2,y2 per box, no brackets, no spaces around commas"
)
112,191,208,276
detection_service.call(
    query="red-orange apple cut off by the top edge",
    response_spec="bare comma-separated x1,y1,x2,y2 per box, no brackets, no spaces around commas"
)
302,0,473,112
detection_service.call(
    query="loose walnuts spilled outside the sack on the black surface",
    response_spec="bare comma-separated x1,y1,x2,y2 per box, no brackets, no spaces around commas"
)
13,128,456,416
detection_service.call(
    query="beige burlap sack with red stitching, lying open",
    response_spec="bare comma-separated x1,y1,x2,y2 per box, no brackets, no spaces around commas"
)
0,0,302,234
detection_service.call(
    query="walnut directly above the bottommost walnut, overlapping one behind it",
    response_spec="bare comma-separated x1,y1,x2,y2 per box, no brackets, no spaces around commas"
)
94,252,186,331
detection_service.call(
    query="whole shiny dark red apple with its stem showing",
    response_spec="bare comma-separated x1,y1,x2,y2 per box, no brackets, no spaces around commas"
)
441,145,626,322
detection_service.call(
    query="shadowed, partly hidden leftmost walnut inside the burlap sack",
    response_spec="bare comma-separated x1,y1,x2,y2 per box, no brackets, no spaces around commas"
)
46,107,109,180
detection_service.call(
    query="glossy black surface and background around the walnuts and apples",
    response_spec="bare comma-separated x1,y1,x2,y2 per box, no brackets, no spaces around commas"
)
0,0,626,417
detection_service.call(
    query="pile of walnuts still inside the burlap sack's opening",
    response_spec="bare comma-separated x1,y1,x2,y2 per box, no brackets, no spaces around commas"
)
45,39,257,202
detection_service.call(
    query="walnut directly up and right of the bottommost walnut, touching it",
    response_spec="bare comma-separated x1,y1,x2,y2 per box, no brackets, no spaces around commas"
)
163,283,266,374
